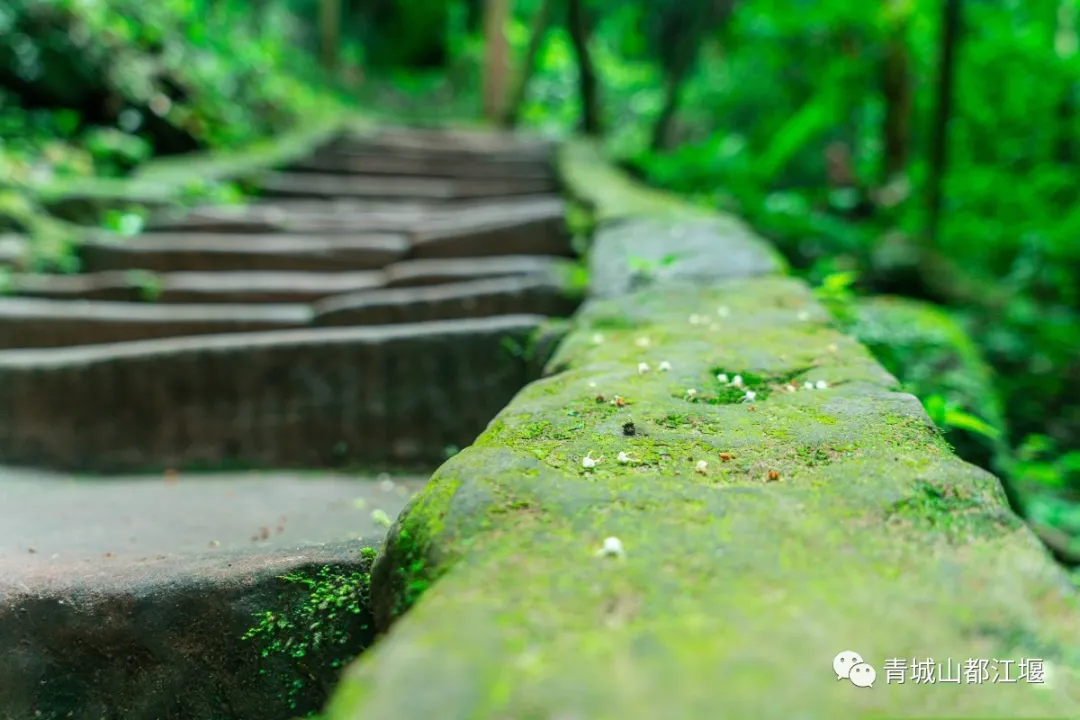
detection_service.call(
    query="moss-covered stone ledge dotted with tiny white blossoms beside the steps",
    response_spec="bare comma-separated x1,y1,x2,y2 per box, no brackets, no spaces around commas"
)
327,138,1080,720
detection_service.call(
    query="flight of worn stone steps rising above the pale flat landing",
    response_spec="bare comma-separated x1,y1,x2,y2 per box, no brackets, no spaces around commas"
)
0,130,577,473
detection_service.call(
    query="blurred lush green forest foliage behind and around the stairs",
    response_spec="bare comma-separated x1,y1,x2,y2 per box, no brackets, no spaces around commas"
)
0,0,1080,552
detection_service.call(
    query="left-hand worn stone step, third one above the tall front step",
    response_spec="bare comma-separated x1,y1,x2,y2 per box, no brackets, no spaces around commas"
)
80,232,409,272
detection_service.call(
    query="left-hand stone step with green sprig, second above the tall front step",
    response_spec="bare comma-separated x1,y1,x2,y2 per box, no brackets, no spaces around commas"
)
10,270,384,303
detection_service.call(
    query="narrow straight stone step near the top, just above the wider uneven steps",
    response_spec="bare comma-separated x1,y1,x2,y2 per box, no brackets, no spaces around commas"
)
259,173,554,201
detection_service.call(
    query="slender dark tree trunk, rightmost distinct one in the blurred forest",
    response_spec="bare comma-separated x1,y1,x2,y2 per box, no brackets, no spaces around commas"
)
922,0,963,249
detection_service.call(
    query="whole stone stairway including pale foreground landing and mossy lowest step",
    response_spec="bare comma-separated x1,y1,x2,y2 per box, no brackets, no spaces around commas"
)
0,131,578,720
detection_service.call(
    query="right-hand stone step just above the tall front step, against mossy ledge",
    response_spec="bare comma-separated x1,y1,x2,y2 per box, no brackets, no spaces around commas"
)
314,275,579,325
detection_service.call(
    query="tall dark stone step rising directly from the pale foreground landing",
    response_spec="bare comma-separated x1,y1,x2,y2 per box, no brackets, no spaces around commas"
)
0,315,544,472
